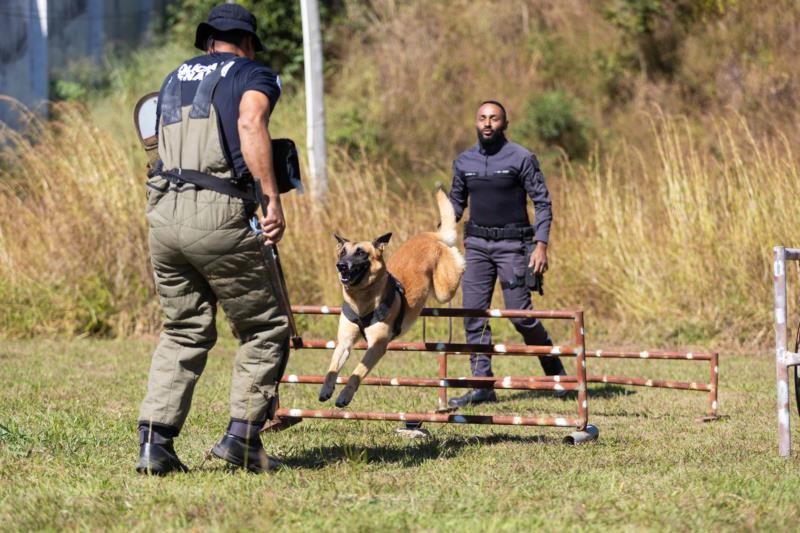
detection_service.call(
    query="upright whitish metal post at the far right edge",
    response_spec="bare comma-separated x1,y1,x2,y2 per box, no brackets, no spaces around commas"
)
773,246,792,457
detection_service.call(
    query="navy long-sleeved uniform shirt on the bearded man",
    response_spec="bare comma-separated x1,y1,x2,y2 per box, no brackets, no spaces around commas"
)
450,139,553,243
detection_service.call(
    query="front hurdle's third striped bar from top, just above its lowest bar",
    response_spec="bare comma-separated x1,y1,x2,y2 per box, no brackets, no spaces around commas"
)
281,374,580,391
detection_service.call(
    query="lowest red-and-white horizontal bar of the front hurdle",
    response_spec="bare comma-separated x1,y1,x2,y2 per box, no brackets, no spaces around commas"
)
276,409,581,427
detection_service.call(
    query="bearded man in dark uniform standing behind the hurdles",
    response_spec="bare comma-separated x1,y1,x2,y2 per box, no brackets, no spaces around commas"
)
448,100,565,407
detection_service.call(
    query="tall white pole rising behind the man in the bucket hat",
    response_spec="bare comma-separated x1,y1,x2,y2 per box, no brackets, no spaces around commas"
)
300,0,328,201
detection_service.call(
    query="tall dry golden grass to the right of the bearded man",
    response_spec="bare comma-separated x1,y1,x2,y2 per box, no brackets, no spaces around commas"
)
551,112,800,345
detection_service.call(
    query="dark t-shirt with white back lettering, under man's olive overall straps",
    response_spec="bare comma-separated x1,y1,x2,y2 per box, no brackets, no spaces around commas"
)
157,53,281,176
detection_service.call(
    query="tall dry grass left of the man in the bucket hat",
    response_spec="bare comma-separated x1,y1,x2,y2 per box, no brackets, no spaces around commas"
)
0,97,157,336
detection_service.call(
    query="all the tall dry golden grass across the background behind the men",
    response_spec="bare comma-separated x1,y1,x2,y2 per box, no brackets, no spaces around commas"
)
0,98,800,344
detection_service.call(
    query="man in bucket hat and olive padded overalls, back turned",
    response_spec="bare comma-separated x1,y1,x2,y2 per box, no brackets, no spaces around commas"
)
136,4,289,475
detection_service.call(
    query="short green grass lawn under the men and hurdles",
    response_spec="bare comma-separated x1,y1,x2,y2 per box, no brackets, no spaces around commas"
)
0,330,800,531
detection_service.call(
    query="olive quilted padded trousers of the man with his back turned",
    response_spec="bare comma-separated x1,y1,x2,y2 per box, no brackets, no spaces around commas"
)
139,176,289,431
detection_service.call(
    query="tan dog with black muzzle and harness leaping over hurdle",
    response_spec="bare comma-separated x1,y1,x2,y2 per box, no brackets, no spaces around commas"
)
319,189,464,407
